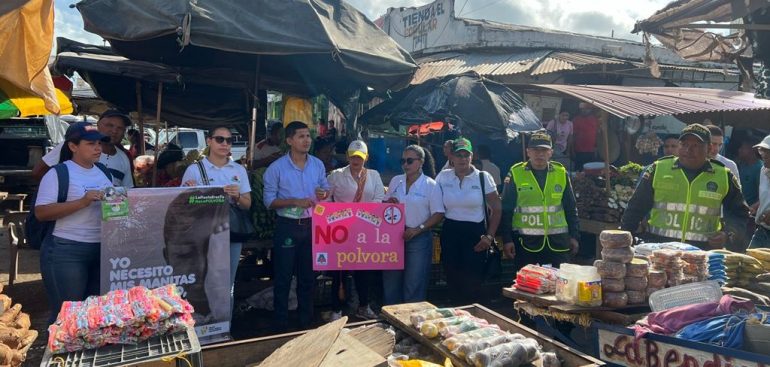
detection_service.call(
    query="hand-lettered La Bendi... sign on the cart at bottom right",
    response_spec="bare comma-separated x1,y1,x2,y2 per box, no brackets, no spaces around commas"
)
599,329,767,367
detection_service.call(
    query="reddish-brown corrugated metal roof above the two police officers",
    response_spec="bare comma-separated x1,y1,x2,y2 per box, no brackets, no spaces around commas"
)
535,84,770,118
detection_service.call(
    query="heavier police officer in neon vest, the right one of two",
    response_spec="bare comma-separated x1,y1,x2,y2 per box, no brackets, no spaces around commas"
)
621,124,749,252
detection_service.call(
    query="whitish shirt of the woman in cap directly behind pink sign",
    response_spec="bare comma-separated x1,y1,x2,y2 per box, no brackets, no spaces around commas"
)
327,166,385,203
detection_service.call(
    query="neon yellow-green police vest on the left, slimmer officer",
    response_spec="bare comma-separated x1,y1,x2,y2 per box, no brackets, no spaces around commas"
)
511,162,569,252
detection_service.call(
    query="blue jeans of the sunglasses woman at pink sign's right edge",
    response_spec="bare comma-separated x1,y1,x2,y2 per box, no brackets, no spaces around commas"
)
382,232,433,305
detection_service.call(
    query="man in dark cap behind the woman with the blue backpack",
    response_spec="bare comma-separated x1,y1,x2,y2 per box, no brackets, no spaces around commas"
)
32,110,134,189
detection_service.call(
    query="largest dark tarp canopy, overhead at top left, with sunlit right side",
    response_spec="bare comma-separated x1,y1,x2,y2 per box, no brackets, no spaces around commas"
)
77,0,417,105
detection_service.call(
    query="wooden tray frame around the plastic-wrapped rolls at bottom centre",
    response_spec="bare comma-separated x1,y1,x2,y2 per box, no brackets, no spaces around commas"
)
382,302,605,367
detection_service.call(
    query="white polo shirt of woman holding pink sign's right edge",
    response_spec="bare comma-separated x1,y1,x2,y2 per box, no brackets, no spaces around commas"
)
385,174,444,228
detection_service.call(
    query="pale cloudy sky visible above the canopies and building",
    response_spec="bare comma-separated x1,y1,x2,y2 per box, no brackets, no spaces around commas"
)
55,0,670,44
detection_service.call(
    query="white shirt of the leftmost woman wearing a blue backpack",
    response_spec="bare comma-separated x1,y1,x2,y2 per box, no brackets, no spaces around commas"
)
35,160,112,243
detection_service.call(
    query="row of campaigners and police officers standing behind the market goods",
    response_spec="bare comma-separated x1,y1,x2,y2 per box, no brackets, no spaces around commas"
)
30,111,770,331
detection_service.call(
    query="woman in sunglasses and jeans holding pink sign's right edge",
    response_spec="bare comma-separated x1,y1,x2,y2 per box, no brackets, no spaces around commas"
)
382,145,444,305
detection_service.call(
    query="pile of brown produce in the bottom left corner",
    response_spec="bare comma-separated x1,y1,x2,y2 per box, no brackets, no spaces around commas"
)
0,284,38,367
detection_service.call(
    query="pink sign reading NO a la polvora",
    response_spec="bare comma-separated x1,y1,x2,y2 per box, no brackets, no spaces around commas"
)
313,203,404,270
